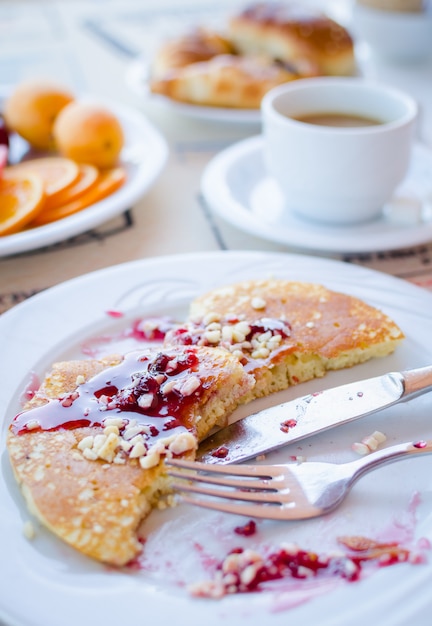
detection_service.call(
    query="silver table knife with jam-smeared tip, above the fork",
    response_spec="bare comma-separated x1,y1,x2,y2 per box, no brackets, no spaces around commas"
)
197,365,432,464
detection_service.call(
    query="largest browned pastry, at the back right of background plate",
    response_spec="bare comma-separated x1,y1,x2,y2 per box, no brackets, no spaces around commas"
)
227,2,355,76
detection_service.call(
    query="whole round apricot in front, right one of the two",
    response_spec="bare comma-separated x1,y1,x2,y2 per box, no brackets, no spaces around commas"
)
53,101,124,169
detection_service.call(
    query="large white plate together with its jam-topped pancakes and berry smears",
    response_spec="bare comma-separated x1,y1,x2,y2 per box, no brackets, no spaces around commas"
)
0,252,432,626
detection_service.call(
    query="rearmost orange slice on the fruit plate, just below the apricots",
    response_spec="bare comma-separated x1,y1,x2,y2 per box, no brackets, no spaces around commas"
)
7,156,79,199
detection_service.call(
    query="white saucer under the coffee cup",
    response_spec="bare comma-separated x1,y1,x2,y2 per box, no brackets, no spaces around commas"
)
201,135,432,253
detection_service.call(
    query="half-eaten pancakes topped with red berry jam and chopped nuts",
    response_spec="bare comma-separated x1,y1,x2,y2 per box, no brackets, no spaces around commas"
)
7,279,404,566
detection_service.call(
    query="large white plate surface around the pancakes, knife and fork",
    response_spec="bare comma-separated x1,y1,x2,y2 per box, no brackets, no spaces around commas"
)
0,252,432,626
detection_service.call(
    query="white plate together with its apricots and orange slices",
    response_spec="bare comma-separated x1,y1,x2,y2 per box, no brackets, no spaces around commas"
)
0,79,168,257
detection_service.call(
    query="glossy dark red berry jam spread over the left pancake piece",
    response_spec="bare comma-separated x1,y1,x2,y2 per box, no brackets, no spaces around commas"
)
11,348,209,437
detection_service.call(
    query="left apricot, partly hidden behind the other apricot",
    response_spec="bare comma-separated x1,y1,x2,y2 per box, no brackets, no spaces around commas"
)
3,80,74,150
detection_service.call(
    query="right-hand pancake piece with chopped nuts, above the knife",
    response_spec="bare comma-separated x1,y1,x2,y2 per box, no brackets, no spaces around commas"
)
165,279,404,401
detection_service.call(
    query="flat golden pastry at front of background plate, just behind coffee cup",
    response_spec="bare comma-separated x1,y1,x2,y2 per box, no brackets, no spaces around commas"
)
151,54,306,109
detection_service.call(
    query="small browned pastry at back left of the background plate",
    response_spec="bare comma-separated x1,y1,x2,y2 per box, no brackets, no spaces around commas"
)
151,27,234,80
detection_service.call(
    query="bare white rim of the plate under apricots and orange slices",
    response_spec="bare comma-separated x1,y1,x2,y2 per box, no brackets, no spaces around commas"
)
0,94,168,256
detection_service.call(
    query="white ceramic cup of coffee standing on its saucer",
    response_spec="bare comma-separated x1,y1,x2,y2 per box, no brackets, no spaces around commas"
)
261,77,417,224
